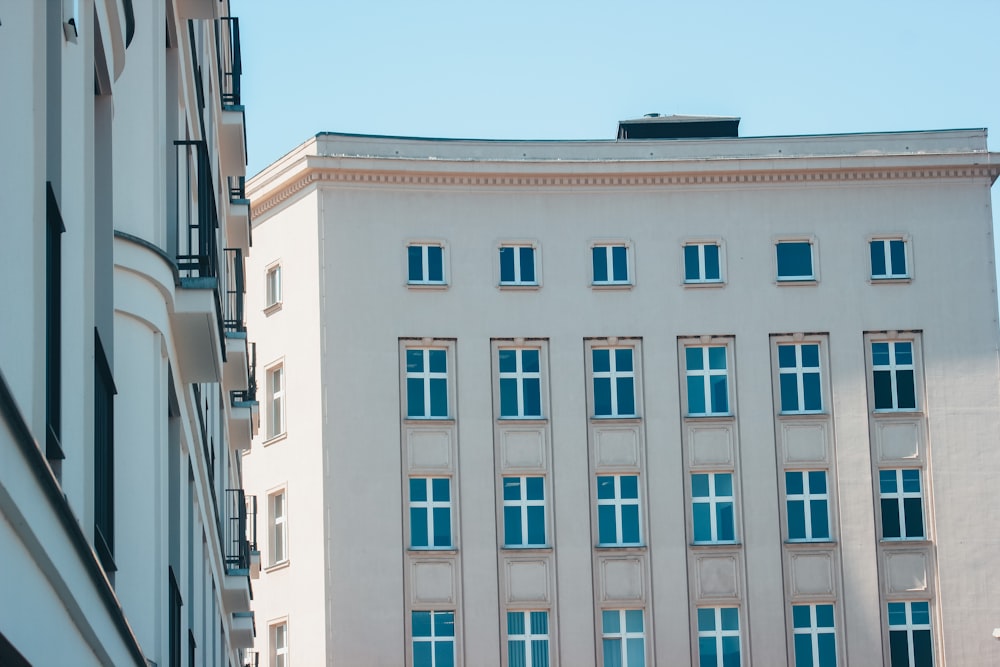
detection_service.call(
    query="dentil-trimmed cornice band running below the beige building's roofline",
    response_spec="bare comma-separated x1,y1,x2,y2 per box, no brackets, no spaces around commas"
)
251,164,1000,219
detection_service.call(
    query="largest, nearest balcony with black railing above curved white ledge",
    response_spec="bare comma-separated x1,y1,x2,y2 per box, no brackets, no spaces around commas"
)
170,141,229,382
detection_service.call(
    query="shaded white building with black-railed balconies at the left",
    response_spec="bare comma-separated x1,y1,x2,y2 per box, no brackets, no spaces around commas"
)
0,0,256,667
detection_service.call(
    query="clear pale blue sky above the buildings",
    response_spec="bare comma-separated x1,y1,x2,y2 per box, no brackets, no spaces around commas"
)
232,0,1000,177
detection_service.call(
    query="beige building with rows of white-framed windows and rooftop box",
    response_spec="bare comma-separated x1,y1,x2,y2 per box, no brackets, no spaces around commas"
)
245,117,1000,667
